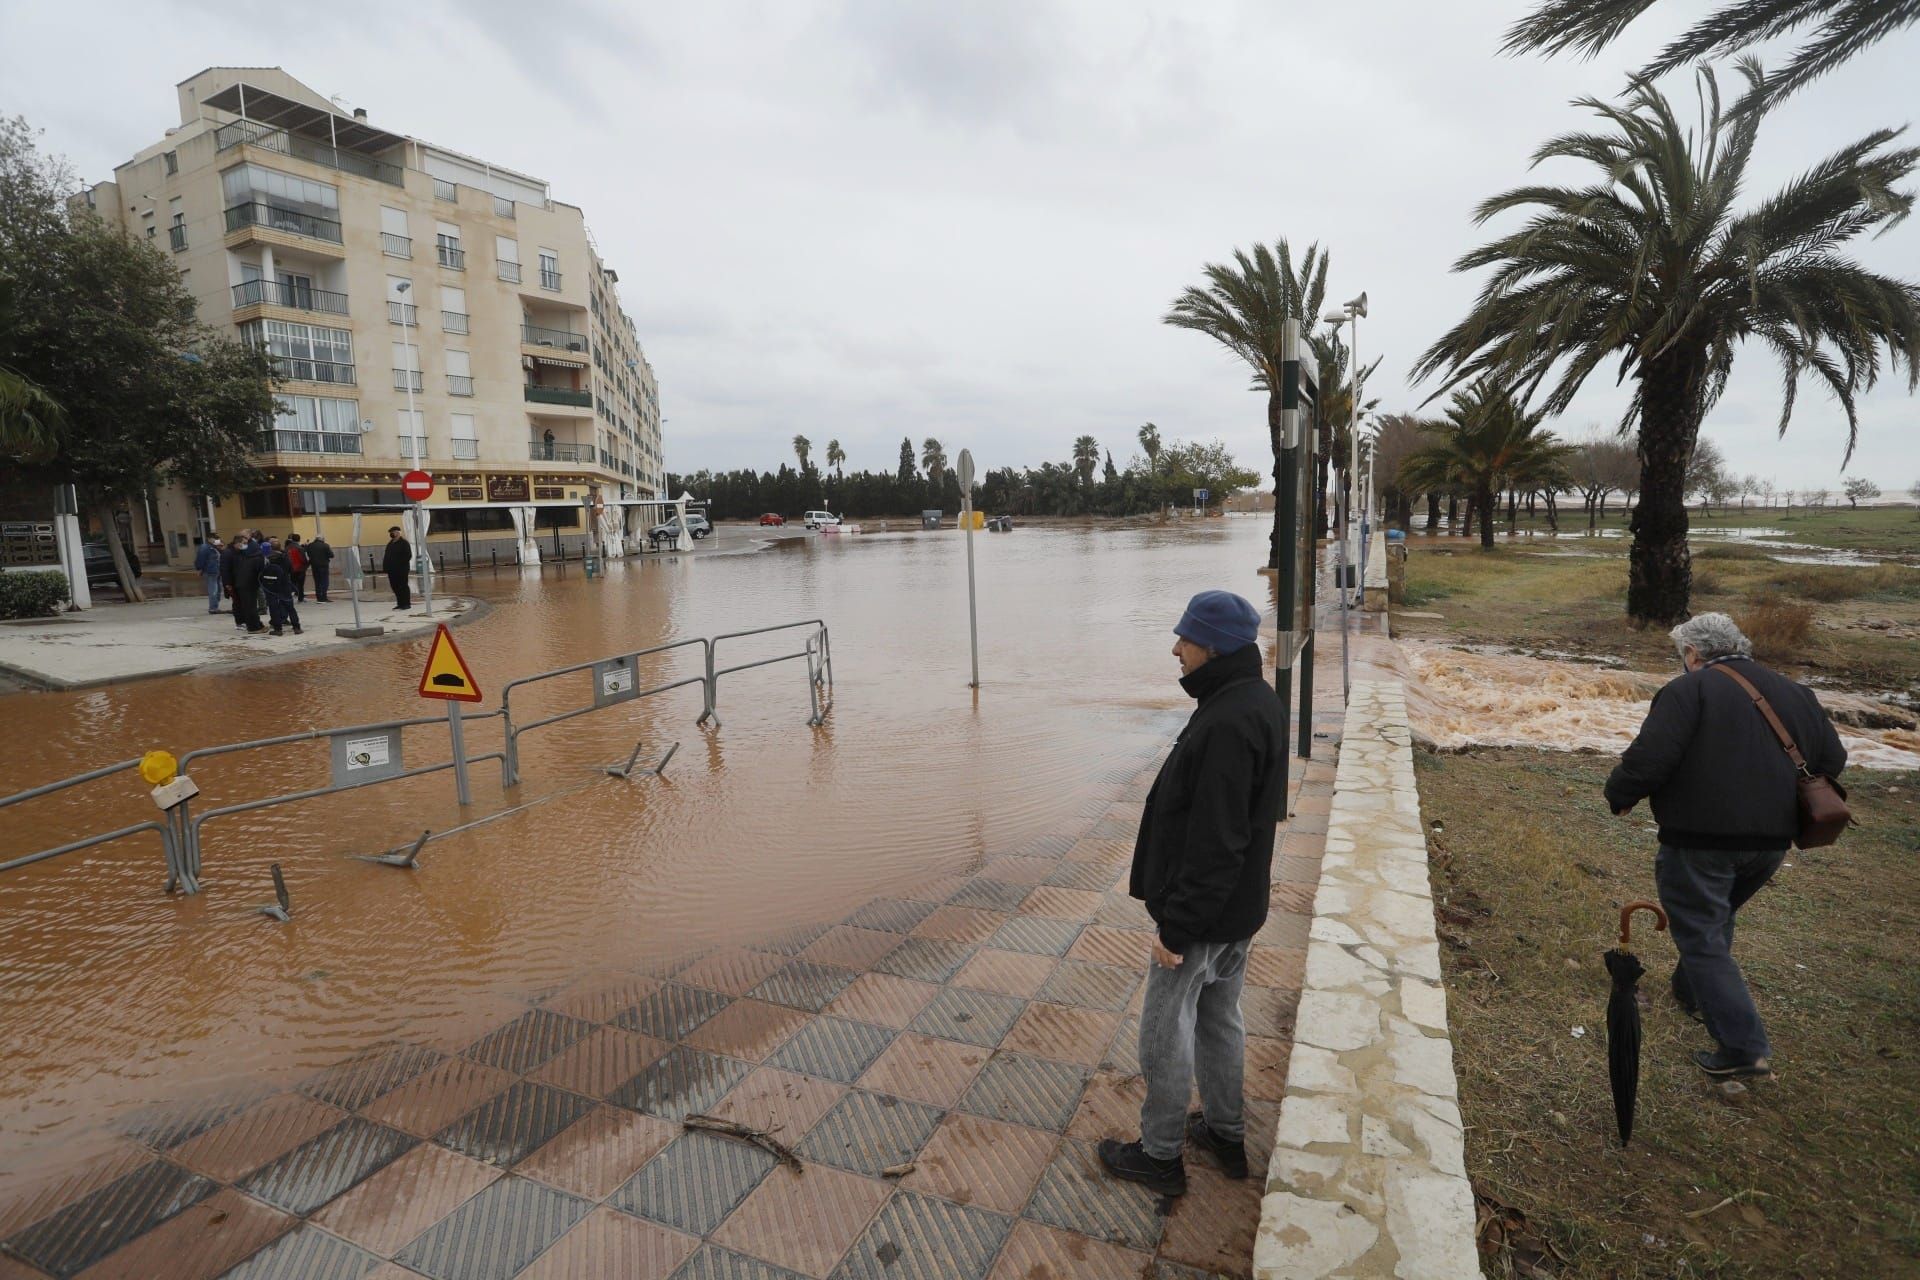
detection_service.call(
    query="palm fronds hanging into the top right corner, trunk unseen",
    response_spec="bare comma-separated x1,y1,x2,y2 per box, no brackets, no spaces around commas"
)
1501,0,1920,106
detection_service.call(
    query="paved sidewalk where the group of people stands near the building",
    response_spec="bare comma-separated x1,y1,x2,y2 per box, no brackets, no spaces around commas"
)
0,591,476,689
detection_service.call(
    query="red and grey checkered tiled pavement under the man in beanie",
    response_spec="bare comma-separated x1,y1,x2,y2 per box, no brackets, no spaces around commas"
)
0,702,1338,1280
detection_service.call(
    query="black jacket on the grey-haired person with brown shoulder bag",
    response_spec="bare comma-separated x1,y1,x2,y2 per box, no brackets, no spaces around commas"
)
1607,658,1847,850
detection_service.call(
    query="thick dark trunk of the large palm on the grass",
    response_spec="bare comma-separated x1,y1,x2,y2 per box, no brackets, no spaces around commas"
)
1626,347,1705,626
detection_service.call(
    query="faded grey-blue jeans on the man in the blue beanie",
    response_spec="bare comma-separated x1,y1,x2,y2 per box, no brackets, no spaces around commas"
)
1140,940,1252,1159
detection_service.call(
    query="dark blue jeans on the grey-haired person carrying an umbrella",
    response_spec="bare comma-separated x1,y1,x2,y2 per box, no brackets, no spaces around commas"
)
1653,844,1788,1057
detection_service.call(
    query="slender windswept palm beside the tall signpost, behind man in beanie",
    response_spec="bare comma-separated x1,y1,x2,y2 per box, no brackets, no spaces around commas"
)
1142,240,1327,568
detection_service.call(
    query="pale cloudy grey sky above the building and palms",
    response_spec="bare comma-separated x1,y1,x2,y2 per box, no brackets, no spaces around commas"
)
0,0,1920,491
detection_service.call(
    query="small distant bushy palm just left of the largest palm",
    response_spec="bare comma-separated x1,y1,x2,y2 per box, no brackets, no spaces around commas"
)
1394,382,1571,551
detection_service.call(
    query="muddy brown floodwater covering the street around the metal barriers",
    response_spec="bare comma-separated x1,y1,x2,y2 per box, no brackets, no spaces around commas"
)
0,518,1267,1201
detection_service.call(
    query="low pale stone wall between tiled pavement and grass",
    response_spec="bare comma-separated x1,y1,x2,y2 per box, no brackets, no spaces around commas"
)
1254,681,1480,1280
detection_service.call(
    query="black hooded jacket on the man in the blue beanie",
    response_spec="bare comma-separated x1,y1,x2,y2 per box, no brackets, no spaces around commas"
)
1127,645,1286,954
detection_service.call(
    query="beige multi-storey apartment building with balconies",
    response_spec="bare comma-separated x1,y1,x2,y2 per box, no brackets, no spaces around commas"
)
86,67,666,564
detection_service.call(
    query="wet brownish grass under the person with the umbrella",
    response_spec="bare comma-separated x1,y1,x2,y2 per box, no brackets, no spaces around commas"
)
1415,750,1920,1280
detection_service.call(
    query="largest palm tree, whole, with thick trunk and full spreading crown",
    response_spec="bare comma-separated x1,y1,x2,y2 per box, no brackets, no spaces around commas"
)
1413,61,1920,624
